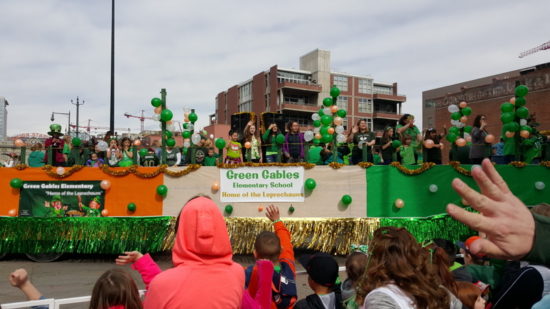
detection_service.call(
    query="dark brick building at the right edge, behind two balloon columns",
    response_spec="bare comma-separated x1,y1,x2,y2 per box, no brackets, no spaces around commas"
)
422,63,550,159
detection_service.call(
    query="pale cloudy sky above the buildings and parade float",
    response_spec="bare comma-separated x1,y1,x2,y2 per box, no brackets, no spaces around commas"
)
0,0,550,135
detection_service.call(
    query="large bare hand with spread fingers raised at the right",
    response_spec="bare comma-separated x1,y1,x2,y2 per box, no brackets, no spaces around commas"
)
447,159,535,259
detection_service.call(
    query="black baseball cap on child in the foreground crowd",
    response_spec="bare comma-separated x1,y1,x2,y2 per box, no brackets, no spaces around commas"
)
298,253,338,287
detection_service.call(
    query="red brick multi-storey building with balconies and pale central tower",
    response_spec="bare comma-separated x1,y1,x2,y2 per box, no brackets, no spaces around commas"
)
207,49,406,131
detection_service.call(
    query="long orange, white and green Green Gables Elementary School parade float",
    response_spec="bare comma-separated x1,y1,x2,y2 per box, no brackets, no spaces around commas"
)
0,87,550,260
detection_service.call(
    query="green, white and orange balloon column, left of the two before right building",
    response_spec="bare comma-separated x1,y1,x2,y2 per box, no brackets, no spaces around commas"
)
448,101,472,148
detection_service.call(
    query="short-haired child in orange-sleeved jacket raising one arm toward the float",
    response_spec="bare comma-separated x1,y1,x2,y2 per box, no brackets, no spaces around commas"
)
245,205,297,308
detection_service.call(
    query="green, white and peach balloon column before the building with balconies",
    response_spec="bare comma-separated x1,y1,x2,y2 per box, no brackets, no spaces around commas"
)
312,86,347,145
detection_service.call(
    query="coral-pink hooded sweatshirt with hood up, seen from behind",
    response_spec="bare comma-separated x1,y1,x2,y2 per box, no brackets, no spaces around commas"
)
143,197,244,309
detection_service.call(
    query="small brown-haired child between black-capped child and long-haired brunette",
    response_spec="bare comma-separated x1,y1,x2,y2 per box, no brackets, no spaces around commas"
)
340,251,368,309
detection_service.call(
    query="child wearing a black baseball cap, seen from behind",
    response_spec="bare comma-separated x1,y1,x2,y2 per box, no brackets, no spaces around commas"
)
294,253,344,309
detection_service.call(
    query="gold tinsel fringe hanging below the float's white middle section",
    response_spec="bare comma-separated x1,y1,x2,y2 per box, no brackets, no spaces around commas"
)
226,218,380,255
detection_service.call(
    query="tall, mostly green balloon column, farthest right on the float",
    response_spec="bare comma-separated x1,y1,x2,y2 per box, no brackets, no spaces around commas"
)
500,85,534,141
